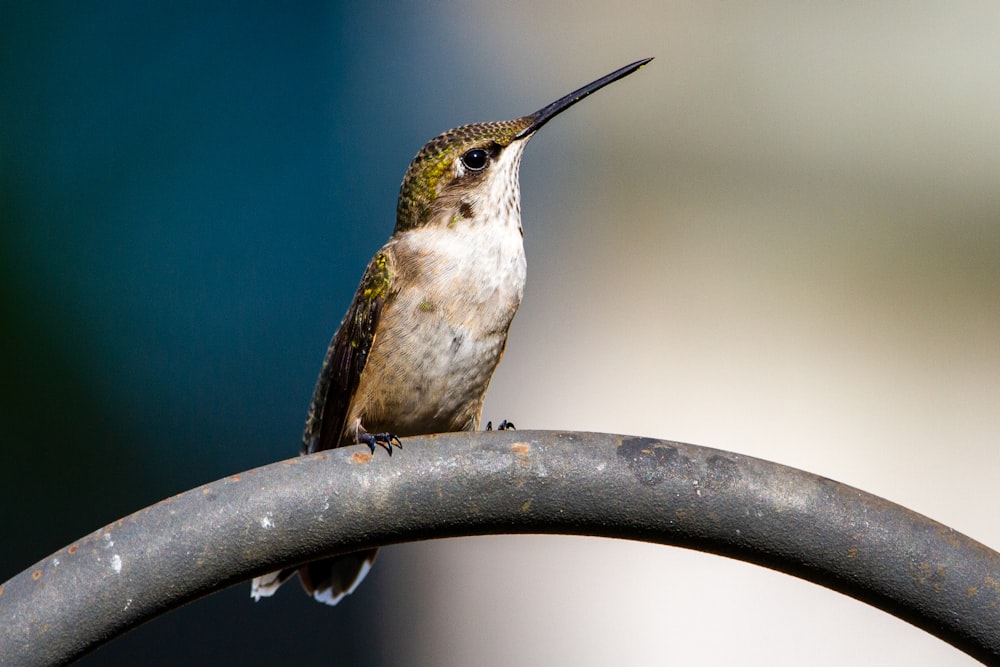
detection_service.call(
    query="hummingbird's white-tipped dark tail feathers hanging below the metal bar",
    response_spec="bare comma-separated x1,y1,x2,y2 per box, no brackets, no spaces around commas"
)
250,549,378,605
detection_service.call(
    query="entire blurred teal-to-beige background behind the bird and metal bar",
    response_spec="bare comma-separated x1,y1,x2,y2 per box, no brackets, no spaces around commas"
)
0,0,1000,666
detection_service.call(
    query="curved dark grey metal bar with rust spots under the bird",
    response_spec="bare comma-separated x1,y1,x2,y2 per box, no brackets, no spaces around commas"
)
0,431,1000,665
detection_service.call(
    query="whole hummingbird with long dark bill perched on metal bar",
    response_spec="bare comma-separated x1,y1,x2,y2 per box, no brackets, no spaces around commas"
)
251,58,652,605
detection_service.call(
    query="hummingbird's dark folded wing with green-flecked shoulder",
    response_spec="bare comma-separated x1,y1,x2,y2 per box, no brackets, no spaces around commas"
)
302,246,395,454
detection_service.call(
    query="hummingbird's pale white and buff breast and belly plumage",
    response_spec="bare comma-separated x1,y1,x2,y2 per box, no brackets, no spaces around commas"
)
350,220,525,436
